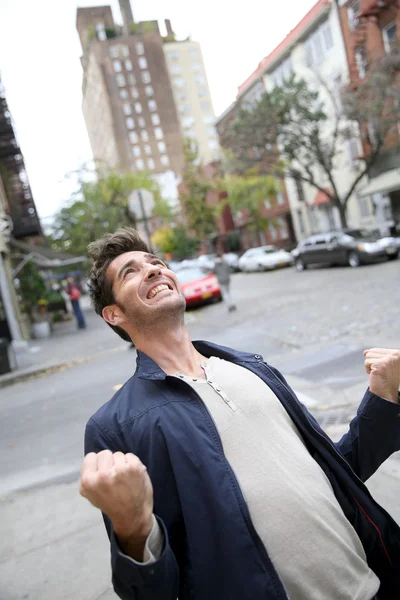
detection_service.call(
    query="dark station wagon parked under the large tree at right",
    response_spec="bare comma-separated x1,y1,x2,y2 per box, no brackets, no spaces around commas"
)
292,229,399,271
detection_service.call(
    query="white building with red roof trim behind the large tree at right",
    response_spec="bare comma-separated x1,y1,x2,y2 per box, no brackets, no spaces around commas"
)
217,0,380,239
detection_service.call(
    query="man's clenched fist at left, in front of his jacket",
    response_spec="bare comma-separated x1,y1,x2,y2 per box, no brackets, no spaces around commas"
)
79,450,153,560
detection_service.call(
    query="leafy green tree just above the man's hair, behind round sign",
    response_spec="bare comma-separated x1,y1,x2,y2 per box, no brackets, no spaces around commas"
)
48,173,161,255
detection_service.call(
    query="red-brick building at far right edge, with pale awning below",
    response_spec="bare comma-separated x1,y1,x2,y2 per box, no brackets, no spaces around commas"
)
339,0,400,233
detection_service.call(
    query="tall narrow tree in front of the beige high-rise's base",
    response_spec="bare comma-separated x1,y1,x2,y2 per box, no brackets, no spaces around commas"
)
180,139,217,241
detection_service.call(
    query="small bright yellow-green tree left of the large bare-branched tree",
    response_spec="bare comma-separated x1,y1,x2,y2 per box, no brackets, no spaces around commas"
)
217,171,279,243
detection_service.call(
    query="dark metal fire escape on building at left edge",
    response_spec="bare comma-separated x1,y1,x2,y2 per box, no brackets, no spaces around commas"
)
0,80,42,239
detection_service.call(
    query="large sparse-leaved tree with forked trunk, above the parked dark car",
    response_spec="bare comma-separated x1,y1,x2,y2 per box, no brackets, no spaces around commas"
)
222,52,400,227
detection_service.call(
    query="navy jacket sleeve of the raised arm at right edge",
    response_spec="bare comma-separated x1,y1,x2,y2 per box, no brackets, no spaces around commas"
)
269,366,400,481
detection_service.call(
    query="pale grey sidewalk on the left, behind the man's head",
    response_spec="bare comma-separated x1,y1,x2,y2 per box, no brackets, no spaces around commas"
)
0,296,127,388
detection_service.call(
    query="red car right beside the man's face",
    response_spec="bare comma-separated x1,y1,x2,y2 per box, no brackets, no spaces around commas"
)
176,267,222,307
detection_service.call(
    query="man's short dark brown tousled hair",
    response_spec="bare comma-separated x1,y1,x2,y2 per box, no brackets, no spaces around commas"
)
88,227,149,342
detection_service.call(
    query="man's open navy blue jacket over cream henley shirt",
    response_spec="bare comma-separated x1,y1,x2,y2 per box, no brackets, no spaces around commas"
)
85,342,400,600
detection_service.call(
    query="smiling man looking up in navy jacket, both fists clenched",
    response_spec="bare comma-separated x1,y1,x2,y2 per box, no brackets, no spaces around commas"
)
80,229,400,600
